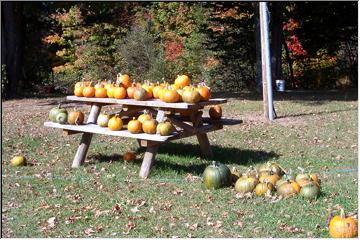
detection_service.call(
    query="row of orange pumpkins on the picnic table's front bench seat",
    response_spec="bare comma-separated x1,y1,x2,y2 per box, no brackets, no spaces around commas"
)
97,111,176,136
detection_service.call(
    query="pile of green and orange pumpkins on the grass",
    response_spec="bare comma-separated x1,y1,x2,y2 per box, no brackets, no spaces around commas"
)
203,162,321,200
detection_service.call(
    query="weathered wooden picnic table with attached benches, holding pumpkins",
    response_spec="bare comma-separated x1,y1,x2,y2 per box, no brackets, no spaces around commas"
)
44,96,227,178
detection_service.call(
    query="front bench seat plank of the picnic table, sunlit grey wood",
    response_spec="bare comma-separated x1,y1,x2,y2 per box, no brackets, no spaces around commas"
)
44,122,175,142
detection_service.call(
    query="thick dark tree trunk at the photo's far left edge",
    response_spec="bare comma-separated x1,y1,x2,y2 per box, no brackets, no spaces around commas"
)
1,2,24,97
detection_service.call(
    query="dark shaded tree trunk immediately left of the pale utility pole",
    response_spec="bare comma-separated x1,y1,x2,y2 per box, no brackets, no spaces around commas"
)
255,3,263,93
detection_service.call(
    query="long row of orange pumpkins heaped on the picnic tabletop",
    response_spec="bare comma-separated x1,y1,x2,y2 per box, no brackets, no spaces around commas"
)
74,74,211,103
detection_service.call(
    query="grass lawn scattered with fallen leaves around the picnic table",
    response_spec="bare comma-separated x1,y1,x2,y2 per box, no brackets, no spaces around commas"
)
1,92,358,238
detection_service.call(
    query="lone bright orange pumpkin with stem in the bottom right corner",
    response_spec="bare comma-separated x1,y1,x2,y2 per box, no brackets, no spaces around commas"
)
329,209,358,238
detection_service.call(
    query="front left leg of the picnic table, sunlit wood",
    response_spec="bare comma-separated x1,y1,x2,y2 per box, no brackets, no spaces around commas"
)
72,104,101,168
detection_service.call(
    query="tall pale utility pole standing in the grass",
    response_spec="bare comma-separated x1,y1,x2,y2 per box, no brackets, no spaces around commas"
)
259,2,275,121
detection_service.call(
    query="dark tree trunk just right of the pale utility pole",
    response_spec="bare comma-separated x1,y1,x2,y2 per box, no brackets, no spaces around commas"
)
271,2,283,87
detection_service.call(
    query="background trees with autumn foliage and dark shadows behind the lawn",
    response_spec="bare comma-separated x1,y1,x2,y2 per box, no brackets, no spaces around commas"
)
2,2,357,97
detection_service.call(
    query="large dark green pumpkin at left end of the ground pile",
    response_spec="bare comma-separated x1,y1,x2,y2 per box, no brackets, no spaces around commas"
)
203,161,231,189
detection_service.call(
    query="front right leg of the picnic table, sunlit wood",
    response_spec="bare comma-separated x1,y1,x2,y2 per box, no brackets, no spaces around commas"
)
139,110,165,179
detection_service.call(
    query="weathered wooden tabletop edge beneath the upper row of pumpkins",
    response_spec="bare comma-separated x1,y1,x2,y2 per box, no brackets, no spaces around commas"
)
66,96,227,109
